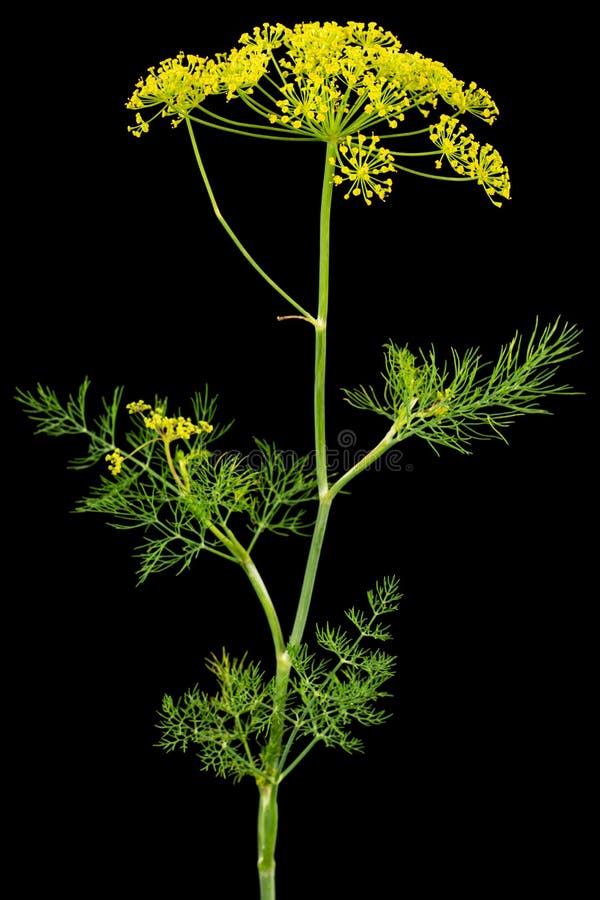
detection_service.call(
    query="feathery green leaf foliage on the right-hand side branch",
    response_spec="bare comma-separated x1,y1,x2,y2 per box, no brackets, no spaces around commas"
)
344,319,581,464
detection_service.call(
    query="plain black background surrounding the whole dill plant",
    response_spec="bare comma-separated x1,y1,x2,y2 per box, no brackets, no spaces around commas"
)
4,3,593,900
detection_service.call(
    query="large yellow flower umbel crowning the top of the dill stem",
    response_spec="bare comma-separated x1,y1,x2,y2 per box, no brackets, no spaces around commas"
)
127,21,510,206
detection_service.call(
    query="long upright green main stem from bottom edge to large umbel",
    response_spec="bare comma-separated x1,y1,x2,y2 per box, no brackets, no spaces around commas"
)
258,143,335,900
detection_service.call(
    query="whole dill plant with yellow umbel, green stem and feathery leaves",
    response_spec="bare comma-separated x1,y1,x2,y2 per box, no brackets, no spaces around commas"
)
17,22,579,900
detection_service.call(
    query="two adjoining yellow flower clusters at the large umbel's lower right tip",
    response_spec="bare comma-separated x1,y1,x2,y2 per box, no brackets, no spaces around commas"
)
429,116,510,206
